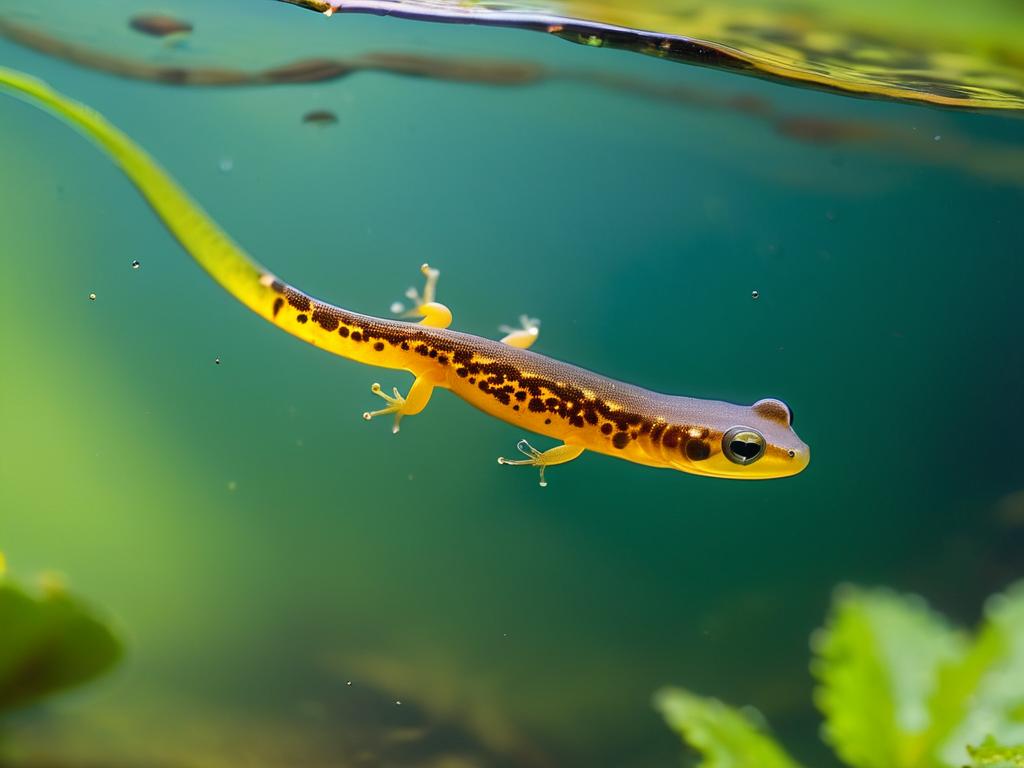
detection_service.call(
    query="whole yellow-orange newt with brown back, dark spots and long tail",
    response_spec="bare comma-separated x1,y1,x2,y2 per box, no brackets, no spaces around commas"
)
0,68,810,486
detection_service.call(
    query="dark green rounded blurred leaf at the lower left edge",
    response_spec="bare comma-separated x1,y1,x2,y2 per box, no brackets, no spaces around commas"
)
0,562,124,714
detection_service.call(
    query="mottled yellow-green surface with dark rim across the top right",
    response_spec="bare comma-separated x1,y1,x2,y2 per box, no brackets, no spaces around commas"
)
285,0,1024,110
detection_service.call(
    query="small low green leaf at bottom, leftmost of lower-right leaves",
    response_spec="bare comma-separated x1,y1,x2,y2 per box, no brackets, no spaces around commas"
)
654,688,800,768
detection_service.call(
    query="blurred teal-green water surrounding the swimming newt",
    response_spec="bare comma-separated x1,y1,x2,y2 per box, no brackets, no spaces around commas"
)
0,0,1024,766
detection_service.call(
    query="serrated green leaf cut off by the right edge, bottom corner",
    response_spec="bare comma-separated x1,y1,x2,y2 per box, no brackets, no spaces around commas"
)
929,582,1024,766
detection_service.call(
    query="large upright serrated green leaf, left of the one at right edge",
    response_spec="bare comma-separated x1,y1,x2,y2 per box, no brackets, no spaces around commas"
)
812,588,965,768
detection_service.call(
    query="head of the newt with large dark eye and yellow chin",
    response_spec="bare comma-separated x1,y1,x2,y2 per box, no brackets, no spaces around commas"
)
672,398,811,480
